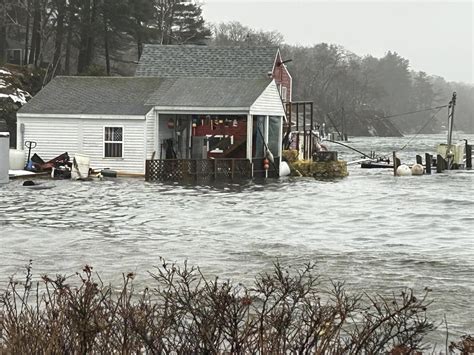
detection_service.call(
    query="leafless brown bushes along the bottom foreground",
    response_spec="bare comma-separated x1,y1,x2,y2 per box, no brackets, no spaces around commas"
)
0,260,469,355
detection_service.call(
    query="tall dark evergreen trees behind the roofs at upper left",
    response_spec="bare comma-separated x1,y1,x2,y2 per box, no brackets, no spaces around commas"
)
0,0,211,75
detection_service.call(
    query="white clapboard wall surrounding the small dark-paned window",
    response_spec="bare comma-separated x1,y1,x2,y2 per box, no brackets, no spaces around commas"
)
18,116,146,174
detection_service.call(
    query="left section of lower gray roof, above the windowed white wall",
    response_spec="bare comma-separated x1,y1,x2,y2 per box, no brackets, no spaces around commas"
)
19,76,160,115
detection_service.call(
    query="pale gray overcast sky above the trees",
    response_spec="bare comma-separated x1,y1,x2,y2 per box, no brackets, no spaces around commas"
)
203,0,474,83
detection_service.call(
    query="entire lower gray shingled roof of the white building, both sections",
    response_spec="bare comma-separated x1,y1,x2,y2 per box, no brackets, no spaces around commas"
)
19,77,272,115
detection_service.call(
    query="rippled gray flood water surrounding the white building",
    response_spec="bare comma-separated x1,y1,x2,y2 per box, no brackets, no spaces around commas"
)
0,135,474,344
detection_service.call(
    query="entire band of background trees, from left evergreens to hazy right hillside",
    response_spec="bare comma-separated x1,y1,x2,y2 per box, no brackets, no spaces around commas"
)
0,0,474,134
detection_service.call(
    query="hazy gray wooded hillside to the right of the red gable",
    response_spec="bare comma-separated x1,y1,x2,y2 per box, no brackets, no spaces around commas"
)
283,43,474,134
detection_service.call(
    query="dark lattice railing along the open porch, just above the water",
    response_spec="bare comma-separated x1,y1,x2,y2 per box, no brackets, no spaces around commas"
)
145,159,252,184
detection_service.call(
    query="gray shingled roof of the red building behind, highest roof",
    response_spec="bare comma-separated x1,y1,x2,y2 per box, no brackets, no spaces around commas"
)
135,44,278,78
